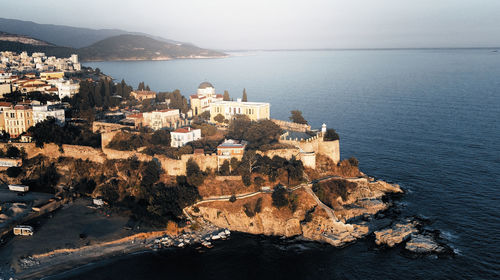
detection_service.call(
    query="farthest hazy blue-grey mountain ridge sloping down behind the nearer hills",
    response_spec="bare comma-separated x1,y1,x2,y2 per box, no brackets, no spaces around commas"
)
0,18,191,49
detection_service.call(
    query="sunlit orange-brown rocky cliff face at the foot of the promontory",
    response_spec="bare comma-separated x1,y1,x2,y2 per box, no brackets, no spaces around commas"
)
186,180,401,246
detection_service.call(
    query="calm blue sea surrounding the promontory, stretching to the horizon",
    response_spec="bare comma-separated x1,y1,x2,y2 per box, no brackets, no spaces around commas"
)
58,50,500,279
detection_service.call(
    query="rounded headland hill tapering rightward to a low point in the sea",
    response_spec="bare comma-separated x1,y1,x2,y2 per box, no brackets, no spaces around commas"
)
78,35,225,61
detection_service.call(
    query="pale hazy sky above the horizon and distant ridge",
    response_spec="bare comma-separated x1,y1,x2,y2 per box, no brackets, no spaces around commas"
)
0,0,500,50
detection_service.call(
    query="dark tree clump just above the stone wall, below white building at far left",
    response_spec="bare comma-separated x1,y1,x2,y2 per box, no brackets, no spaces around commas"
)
28,118,101,148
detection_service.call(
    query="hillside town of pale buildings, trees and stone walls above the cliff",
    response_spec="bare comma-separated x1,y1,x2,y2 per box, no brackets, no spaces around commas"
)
0,52,392,278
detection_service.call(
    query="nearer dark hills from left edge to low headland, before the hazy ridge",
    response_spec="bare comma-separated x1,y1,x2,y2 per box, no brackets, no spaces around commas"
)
0,32,225,61
